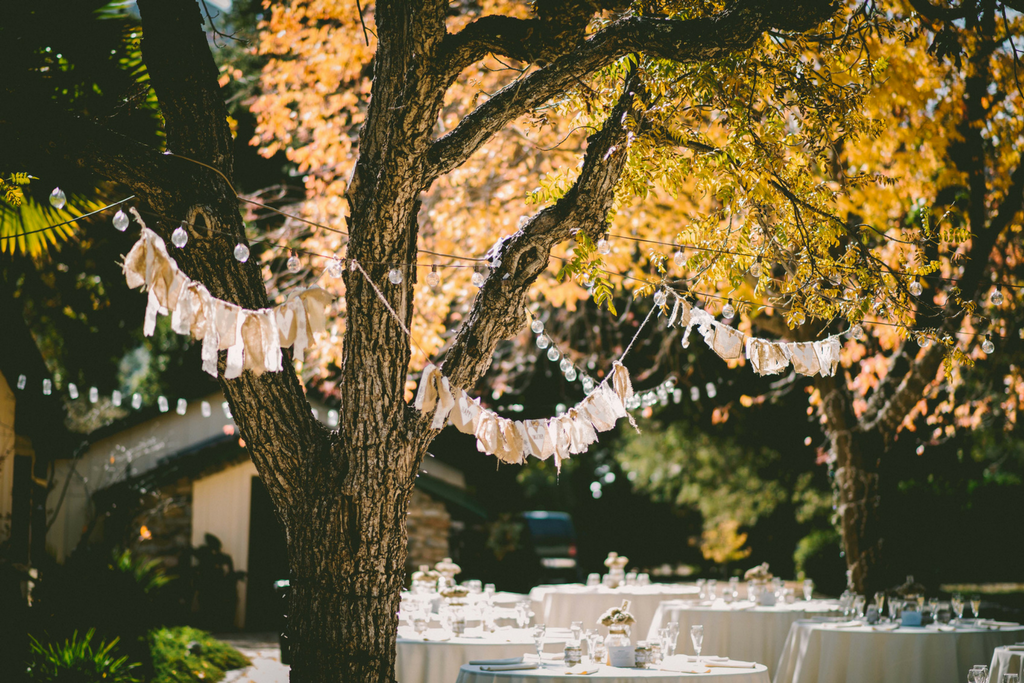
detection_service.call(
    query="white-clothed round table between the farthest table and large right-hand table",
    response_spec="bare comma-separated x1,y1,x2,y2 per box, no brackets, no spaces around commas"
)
647,600,839,675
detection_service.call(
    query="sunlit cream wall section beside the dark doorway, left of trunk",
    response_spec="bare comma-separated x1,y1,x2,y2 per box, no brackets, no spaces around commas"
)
191,461,256,628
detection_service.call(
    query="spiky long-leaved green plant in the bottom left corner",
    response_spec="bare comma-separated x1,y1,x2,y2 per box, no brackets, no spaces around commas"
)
27,629,139,683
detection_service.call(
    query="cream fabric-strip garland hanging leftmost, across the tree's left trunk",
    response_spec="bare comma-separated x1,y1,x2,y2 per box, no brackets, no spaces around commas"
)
124,209,334,379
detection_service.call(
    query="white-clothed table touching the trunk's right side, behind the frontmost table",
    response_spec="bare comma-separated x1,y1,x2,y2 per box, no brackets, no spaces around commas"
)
395,628,557,683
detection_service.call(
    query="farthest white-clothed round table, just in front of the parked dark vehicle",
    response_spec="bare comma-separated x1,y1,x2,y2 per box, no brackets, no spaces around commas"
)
529,584,700,639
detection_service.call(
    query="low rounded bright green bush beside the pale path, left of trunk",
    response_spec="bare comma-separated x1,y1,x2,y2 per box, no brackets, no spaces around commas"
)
150,626,250,683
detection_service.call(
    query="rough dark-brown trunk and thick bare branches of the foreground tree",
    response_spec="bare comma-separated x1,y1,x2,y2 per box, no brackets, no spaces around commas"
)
0,0,837,683
